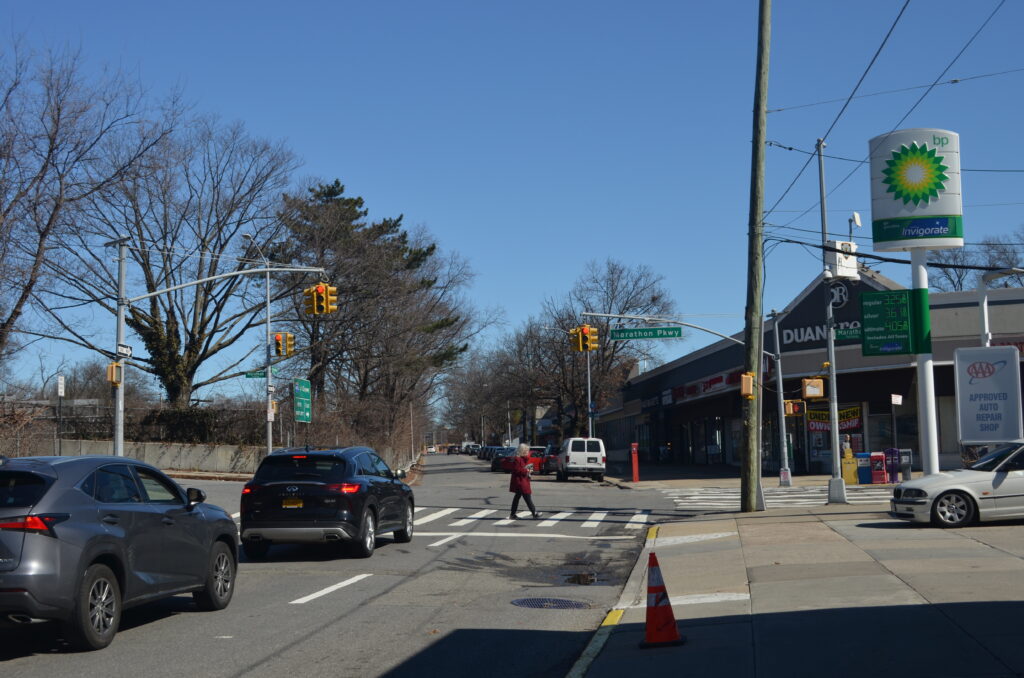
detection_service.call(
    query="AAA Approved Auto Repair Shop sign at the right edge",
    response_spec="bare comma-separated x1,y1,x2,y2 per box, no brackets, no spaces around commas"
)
953,346,1024,444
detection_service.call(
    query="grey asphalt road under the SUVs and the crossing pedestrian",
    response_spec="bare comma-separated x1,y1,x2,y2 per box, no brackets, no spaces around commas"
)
0,455,678,678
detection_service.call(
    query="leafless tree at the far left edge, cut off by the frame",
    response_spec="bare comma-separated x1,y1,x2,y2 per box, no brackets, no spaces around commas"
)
0,44,175,354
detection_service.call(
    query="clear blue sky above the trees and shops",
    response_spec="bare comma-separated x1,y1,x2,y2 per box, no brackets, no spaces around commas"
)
0,0,1024,395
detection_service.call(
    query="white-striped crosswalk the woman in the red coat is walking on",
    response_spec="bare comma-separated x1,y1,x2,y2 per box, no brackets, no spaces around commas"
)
415,506,651,529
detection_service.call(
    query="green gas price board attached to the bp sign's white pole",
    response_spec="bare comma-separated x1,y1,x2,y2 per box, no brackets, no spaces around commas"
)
860,290,932,355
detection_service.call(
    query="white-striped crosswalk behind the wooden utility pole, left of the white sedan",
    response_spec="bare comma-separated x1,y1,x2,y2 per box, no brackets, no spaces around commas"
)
662,485,893,511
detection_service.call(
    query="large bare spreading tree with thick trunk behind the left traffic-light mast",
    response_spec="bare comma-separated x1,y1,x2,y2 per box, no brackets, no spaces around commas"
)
37,117,296,407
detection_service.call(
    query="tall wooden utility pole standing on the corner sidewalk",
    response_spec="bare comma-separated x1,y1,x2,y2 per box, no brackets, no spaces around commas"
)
739,0,771,513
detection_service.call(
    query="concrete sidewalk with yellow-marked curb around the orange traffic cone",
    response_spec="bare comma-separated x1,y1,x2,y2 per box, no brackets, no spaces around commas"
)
569,499,1024,678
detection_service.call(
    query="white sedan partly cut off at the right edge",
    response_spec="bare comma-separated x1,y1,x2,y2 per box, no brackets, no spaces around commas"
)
889,442,1024,527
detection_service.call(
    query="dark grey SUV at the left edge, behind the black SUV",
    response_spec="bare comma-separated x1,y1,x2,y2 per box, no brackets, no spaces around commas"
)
0,456,238,650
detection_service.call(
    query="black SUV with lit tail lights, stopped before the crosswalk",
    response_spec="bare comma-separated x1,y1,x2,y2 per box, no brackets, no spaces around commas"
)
242,448,415,559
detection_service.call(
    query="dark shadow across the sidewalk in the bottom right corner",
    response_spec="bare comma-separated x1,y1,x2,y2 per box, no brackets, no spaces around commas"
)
587,592,1024,678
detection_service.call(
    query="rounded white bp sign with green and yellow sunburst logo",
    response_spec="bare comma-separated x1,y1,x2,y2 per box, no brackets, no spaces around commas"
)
868,128,964,252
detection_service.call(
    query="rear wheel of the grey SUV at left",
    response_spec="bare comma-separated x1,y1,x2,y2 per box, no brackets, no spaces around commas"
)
67,563,121,650
